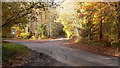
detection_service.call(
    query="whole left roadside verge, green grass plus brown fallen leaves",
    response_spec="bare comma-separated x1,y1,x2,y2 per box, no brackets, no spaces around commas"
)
2,42,32,68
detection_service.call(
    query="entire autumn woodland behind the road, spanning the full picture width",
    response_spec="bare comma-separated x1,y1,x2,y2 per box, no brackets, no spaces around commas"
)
0,0,120,45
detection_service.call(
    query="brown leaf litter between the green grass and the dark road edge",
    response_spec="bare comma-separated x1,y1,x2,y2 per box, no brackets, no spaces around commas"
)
2,49,33,67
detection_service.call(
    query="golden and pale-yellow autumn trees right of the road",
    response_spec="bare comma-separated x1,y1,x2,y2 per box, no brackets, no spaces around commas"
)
58,0,120,44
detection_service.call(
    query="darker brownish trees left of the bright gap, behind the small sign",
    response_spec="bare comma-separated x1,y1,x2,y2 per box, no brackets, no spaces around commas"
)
2,2,63,39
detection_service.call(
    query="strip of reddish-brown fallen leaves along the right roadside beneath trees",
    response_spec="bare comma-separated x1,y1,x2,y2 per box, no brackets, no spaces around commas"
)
64,40,120,57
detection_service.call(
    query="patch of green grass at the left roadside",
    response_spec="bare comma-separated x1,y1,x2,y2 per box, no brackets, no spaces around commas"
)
2,43,27,62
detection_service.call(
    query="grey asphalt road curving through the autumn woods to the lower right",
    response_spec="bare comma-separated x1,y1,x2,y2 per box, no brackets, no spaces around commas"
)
6,38,118,66
